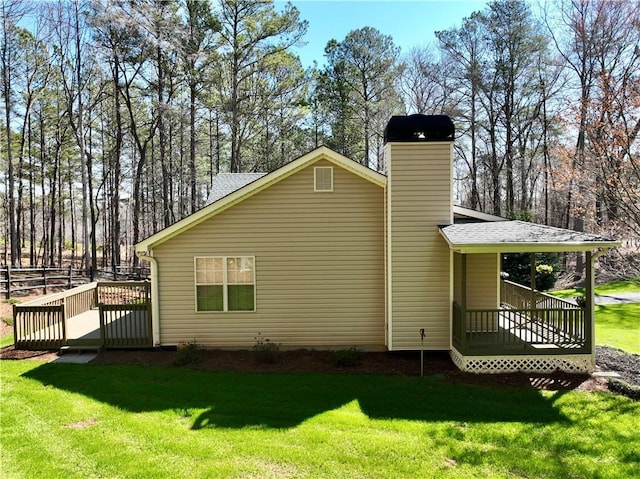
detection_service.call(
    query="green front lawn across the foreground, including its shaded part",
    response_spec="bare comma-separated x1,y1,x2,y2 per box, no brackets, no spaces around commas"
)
0,361,640,479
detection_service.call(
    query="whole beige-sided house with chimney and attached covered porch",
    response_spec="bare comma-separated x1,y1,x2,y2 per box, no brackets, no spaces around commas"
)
136,115,617,372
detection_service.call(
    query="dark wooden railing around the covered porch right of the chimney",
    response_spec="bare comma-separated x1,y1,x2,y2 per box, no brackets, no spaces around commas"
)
453,281,591,356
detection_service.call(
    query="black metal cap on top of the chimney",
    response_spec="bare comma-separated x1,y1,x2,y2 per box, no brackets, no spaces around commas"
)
384,114,455,143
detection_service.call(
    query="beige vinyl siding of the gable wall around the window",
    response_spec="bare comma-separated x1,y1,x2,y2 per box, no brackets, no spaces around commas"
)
154,160,385,348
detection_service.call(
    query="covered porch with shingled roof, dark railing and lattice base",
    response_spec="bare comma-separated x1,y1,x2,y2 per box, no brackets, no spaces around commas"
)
441,220,617,373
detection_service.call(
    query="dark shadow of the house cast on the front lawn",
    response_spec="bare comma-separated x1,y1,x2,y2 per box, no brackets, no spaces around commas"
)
23,364,568,429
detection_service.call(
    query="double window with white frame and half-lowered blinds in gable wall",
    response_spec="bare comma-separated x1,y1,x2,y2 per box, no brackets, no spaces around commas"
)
195,256,256,311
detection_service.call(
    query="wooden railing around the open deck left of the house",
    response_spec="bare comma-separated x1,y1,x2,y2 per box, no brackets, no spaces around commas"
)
13,281,151,349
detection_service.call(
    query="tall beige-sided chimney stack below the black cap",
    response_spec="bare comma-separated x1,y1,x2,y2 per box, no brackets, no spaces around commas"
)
385,142,453,350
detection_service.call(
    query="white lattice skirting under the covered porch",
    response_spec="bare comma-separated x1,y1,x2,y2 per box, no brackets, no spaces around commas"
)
451,348,594,374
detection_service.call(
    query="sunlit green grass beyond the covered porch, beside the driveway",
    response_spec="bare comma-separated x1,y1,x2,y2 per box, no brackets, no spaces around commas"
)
551,279,640,354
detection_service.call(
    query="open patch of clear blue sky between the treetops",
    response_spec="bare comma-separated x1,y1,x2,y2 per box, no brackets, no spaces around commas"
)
276,0,487,67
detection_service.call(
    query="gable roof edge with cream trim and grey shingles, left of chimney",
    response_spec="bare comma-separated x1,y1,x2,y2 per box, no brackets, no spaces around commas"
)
135,146,387,253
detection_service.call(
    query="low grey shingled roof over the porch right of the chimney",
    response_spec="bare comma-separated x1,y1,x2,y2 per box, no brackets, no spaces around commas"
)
440,220,620,253
